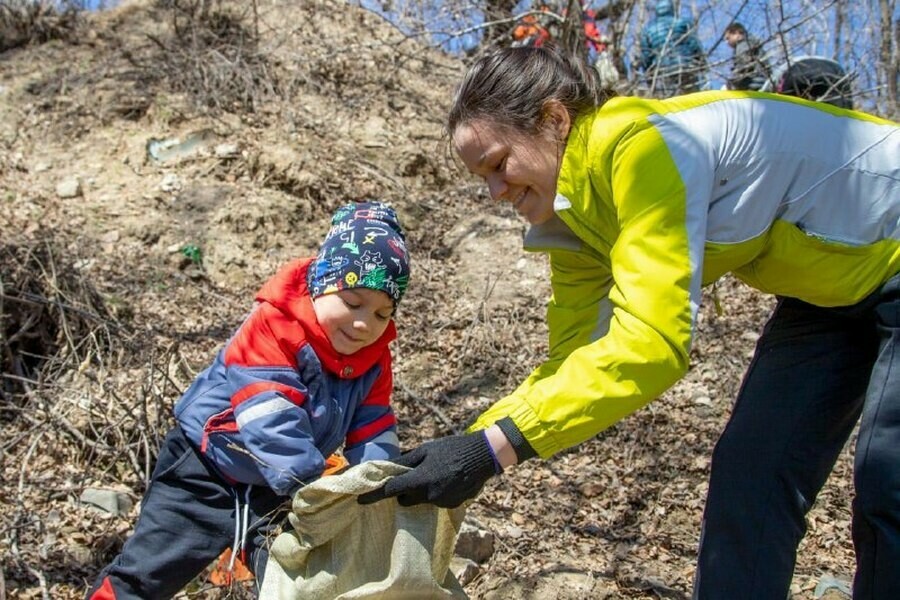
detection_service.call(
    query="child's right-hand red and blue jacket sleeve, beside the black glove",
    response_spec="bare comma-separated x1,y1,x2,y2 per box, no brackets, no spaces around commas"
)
344,350,400,465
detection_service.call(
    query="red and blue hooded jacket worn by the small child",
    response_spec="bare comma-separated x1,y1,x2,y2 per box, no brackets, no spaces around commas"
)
175,259,400,496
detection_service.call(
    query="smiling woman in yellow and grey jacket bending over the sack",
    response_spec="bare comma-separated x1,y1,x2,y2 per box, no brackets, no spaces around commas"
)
361,48,900,600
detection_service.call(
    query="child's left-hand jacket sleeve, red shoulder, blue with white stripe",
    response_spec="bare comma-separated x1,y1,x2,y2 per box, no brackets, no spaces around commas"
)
225,303,325,495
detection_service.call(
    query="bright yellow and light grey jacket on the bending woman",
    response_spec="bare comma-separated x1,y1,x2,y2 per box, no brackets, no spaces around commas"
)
472,92,900,457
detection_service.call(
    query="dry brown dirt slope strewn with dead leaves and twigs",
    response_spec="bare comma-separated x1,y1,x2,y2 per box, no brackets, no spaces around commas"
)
0,0,854,600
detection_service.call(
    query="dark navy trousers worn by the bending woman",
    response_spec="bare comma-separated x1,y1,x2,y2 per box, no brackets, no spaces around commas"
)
694,276,900,600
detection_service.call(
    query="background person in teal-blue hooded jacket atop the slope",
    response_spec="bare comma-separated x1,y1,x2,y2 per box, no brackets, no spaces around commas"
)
640,0,707,98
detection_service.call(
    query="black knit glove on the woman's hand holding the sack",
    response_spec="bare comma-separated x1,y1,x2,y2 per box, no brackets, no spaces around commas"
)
358,431,503,508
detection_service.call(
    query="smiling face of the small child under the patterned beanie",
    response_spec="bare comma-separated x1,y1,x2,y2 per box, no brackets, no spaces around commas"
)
313,288,394,354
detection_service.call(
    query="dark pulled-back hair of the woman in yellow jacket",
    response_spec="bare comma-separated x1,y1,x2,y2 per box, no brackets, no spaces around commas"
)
447,44,611,136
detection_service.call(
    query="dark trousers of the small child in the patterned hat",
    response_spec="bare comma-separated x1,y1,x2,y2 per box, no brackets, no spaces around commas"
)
87,426,287,600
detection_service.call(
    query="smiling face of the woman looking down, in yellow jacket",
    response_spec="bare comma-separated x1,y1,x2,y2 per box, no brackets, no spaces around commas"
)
453,106,569,225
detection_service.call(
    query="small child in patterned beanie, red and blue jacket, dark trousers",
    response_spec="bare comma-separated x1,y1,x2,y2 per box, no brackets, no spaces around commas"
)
87,202,409,600
